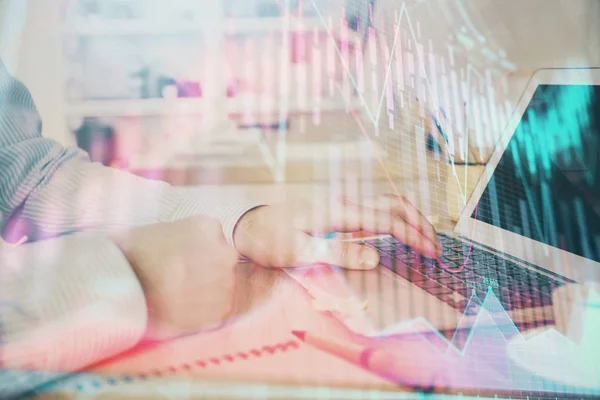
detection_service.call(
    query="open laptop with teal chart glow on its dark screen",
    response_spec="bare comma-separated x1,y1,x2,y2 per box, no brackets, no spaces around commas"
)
344,69,600,337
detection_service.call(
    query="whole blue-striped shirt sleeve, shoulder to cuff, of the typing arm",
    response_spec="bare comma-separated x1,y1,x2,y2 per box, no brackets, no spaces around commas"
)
0,63,259,244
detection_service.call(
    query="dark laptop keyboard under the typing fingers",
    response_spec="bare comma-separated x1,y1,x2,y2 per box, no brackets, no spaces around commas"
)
365,234,564,315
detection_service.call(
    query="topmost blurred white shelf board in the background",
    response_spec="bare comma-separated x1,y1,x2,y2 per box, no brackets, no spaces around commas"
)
63,17,325,36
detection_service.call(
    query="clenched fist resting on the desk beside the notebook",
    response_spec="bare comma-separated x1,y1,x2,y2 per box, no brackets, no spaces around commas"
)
113,216,238,339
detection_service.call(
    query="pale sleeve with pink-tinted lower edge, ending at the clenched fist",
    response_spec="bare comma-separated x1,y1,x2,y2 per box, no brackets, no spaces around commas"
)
0,233,147,372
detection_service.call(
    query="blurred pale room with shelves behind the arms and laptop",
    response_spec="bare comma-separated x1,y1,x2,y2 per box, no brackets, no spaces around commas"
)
0,0,600,219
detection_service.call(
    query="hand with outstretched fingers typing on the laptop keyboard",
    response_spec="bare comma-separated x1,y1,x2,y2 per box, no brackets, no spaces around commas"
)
234,195,442,269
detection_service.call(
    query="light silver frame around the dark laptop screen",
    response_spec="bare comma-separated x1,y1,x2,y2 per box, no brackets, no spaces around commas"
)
454,68,600,282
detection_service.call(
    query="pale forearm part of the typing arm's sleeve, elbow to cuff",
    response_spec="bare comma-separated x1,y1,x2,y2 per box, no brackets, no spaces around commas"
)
22,159,258,243
